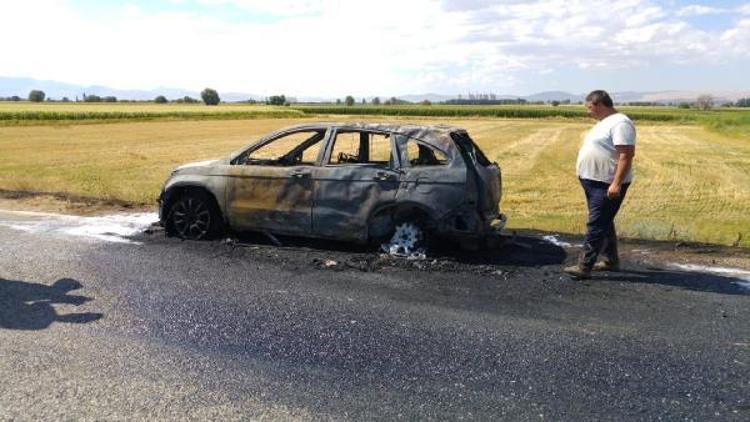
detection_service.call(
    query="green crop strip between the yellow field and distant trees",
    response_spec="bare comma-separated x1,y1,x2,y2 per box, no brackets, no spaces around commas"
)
5,101,750,139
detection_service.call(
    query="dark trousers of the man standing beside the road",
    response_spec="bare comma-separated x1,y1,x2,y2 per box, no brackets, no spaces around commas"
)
579,179,630,270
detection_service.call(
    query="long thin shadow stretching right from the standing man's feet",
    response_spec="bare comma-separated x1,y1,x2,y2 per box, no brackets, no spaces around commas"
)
606,268,750,295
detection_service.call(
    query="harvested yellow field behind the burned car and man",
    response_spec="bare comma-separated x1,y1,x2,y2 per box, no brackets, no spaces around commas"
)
0,115,750,247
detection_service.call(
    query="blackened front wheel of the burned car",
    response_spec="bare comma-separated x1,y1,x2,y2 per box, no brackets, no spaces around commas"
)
169,192,222,240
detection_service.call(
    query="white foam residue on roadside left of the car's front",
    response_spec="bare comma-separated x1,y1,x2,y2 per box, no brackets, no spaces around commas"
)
0,211,158,244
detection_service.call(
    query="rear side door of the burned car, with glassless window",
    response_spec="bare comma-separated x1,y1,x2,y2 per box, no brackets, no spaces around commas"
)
312,129,400,240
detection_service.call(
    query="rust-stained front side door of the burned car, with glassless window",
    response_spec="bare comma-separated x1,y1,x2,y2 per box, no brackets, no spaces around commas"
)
226,129,326,235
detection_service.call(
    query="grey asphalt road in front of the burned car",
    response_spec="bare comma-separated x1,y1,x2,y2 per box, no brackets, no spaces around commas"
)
0,213,750,421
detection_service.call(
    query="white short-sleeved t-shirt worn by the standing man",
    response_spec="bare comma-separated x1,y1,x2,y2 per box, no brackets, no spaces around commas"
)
576,113,635,183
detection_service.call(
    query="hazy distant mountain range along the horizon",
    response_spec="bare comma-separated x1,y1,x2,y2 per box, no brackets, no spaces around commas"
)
0,76,750,103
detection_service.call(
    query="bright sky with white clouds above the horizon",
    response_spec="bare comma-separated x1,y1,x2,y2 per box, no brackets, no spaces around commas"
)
0,0,750,97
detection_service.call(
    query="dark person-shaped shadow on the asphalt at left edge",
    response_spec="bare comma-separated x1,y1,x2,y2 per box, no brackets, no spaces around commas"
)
0,278,102,330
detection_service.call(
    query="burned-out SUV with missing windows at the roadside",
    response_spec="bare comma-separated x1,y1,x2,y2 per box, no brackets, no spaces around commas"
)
159,123,505,251
